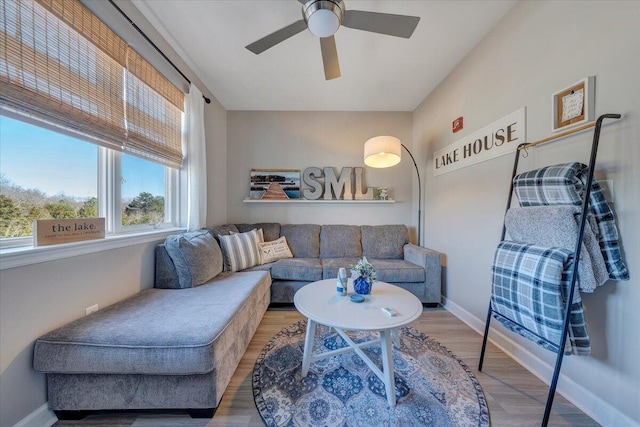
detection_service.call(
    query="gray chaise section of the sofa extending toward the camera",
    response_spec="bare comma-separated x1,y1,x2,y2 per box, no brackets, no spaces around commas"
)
34,271,271,416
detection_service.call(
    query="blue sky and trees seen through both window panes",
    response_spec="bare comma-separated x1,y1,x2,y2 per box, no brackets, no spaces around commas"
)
0,116,165,238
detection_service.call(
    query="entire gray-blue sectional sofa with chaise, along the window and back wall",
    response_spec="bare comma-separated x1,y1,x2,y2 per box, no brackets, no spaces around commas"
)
34,223,440,417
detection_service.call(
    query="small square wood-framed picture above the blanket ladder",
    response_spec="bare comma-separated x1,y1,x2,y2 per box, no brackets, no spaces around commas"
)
551,76,596,132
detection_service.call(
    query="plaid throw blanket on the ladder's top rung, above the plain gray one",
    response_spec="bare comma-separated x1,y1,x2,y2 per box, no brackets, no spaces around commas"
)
513,162,629,280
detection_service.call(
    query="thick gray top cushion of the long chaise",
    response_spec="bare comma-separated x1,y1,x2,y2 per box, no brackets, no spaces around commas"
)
33,271,271,378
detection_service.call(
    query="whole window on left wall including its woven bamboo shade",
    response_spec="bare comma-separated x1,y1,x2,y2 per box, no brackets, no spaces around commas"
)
0,0,184,246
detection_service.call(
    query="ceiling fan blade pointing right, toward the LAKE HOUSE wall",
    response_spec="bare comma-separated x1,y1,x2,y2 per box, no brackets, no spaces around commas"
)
342,10,420,39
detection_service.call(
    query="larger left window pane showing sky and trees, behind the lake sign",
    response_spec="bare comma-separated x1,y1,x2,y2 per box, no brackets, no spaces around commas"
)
0,116,98,239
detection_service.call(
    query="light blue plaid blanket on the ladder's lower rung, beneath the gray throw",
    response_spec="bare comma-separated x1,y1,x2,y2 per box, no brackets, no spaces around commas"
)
491,241,591,356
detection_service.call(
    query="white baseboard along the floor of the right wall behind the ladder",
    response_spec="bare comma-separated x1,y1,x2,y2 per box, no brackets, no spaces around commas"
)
442,297,640,427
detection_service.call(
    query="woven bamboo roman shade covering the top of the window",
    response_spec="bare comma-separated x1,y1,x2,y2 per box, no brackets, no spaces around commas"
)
0,0,184,167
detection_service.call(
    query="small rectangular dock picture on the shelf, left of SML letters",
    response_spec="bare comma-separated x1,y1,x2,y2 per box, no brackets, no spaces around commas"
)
249,169,300,200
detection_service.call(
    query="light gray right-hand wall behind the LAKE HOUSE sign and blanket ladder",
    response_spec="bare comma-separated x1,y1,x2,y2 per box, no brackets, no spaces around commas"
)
414,1,640,426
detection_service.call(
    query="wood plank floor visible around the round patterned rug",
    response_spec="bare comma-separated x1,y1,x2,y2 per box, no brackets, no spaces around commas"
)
55,308,599,427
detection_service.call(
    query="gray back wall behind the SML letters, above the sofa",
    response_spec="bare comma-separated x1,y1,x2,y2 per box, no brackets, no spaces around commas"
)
227,111,417,241
